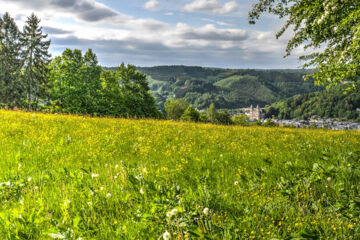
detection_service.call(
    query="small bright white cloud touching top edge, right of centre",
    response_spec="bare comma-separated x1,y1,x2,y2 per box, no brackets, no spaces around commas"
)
183,0,239,14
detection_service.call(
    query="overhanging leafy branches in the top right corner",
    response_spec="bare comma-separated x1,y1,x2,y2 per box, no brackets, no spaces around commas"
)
249,0,360,87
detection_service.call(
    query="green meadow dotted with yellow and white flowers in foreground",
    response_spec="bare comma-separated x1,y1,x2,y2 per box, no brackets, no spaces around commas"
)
0,110,360,240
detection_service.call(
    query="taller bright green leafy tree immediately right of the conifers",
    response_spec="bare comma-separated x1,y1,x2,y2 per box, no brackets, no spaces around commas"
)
49,49,102,114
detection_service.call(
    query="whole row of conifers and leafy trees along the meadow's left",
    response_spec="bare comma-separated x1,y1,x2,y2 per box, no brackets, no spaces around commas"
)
0,13,161,118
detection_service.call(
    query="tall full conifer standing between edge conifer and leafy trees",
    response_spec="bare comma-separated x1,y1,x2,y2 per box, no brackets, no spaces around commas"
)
20,13,51,110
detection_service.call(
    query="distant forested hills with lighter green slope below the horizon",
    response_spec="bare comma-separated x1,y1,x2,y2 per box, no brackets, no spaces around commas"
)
128,66,321,109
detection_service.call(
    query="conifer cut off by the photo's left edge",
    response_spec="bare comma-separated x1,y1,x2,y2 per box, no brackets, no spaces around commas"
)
0,13,23,107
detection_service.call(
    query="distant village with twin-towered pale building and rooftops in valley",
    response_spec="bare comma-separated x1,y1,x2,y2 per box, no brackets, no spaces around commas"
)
238,105,360,130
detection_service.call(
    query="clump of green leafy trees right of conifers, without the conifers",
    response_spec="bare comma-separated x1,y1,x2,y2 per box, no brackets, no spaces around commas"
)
49,49,160,118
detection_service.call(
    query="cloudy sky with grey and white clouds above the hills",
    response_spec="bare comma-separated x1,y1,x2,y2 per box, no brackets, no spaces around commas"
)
0,0,301,69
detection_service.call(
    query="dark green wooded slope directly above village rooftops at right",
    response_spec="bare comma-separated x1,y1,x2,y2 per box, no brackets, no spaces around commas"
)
265,84,360,120
